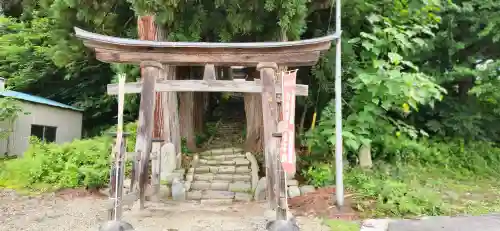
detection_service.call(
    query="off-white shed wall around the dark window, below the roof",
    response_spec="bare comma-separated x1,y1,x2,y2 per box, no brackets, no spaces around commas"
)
0,102,83,155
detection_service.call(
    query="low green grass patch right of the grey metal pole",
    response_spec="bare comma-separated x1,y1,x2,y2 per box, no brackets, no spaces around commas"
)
345,165,500,218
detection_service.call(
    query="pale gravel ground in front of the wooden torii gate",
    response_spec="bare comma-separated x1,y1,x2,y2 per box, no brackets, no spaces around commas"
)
0,189,329,231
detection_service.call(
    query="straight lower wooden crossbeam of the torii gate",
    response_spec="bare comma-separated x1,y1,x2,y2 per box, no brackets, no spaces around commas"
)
108,80,309,96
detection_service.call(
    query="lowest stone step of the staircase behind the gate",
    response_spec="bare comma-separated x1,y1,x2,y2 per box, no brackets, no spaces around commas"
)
186,190,252,201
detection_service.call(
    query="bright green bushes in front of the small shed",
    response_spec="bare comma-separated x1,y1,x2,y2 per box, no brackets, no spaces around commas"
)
0,123,136,190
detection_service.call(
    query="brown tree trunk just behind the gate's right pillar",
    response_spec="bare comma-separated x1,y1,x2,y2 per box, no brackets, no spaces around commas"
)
244,68,264,152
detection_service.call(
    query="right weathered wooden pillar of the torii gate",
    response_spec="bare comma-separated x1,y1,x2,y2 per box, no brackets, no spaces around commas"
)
257,63,279,209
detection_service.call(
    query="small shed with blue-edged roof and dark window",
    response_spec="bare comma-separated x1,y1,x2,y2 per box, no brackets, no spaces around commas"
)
0,78,83,156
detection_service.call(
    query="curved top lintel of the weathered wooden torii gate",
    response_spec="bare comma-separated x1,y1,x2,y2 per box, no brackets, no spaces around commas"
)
75,28,339,66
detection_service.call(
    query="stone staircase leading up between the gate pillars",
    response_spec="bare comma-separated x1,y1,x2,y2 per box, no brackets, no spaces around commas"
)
186,148,258,202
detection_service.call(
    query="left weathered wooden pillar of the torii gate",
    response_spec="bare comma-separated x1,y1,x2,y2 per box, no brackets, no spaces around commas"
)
135,62,158,209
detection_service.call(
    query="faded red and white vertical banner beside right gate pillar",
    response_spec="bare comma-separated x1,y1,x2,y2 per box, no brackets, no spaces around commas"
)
280,70,297,174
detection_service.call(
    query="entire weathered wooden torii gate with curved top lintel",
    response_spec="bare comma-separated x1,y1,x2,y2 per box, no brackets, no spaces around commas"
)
75,28,340,222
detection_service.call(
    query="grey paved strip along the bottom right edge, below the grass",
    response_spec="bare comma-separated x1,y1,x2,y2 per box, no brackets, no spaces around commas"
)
361,214,500,231
